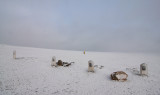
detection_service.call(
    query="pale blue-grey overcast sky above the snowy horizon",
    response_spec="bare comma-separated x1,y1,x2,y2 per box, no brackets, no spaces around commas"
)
0,0,160,52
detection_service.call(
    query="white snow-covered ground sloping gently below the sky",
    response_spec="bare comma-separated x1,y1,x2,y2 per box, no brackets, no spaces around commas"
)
0,45,160,95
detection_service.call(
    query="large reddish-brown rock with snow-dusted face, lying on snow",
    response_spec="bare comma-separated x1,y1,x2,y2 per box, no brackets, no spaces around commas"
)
111,71,128,81
